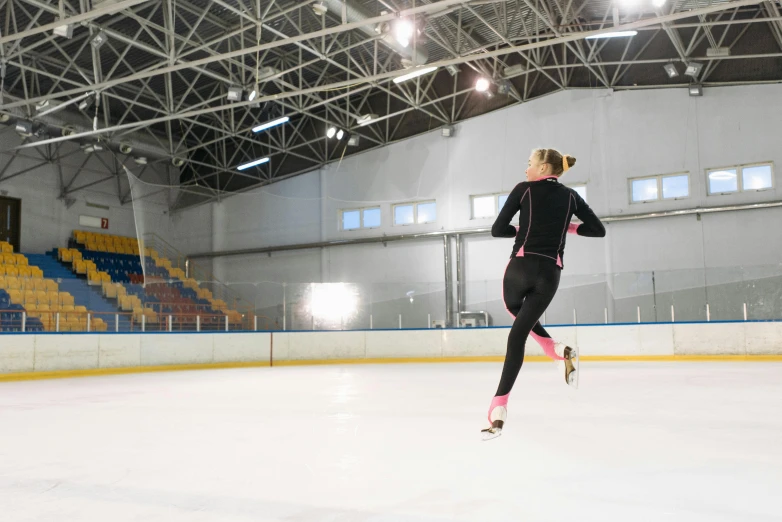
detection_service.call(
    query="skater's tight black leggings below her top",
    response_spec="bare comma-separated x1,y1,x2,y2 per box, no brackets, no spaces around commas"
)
496,254,562,396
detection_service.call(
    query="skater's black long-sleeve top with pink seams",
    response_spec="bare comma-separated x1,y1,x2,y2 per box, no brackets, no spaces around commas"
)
491,176,606,267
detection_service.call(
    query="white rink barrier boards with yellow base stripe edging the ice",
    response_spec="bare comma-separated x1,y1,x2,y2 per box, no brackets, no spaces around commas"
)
0,322,782,379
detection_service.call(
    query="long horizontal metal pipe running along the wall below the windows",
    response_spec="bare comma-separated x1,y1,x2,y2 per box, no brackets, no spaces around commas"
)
188,201,782,260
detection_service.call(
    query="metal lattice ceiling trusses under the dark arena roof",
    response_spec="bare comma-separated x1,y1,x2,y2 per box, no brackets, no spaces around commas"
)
0,0,782,209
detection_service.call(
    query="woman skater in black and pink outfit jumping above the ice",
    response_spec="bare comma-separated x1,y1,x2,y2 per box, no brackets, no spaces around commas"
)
483,149,605,440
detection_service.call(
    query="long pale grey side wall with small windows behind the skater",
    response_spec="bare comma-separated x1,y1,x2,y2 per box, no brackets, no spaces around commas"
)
176,85,782,320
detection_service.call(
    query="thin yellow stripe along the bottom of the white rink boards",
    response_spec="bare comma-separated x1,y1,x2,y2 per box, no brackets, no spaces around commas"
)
0,355,782,382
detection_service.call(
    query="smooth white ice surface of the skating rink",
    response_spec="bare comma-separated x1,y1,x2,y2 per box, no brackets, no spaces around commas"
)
0,362,782,522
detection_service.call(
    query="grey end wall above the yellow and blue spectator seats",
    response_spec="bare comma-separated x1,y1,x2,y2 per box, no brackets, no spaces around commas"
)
0,126,213,254
